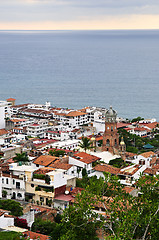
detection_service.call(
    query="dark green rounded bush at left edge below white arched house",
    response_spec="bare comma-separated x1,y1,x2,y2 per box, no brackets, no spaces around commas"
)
0,199,23,217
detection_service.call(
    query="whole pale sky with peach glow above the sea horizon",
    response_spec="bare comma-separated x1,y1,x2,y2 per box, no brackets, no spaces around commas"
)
0,0,159,30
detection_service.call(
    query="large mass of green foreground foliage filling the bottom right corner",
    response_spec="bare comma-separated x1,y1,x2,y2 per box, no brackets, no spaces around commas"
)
63,174,159,240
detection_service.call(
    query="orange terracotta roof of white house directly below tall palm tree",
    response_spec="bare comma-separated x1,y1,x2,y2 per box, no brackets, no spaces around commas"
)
73,152,101,164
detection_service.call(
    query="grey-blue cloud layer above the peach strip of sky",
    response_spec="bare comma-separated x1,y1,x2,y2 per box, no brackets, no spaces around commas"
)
0,0,159,22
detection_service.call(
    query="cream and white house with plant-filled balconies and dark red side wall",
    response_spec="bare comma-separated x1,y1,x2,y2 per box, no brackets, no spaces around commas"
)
25,167,67,206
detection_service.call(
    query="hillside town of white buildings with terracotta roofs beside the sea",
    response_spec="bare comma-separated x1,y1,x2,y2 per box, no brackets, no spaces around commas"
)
0,98,159,240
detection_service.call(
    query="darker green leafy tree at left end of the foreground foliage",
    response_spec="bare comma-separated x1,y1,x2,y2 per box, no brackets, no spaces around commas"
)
60,188,100,240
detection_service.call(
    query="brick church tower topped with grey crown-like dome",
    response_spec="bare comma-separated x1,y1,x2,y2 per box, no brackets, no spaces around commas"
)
102,107,119,154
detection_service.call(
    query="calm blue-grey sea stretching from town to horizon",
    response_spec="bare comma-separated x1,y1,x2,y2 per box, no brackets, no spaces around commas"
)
0,30,159,120
